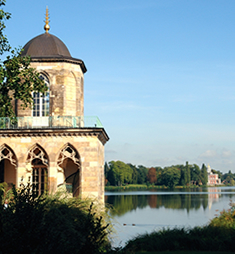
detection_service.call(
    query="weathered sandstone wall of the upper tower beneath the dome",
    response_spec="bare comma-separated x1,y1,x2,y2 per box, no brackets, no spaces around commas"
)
13,62,84,116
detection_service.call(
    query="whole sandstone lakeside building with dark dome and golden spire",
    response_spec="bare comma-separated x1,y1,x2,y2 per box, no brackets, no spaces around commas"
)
0,11,109,201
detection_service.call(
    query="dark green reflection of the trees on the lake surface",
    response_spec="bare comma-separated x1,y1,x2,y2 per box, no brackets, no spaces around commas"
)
106,194,208,216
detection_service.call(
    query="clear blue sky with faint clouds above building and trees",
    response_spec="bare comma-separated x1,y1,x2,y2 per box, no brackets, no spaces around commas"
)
4,0,235,173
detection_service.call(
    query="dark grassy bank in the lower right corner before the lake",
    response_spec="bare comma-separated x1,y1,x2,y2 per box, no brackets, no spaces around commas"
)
122,204,235,253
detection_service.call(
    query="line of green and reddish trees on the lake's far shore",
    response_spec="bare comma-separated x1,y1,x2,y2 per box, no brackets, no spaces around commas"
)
105,161,235,188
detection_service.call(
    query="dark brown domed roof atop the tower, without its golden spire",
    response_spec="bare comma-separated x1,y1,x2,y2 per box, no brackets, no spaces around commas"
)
21,32,71,58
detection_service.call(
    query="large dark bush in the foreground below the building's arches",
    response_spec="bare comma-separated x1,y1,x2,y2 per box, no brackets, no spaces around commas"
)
0,186,110,254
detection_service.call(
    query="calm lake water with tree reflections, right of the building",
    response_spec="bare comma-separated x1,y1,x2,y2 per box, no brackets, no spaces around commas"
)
105,187,235,246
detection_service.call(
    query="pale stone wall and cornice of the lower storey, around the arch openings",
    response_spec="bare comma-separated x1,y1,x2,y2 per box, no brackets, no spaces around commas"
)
0,129,108,202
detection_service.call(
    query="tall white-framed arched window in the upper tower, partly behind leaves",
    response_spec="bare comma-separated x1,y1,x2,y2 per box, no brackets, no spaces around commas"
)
32,74,50,117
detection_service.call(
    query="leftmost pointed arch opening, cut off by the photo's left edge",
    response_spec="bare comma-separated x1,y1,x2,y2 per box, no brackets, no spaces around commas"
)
0,144,17,188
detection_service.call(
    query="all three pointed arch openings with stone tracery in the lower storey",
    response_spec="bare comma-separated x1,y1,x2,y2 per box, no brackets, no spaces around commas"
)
0,144,80,196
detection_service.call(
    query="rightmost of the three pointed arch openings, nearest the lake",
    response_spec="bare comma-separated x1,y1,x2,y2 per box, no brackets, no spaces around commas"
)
57,143,81,197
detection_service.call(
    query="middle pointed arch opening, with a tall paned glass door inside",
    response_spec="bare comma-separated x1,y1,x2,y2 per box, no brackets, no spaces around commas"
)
27,144,49,196
